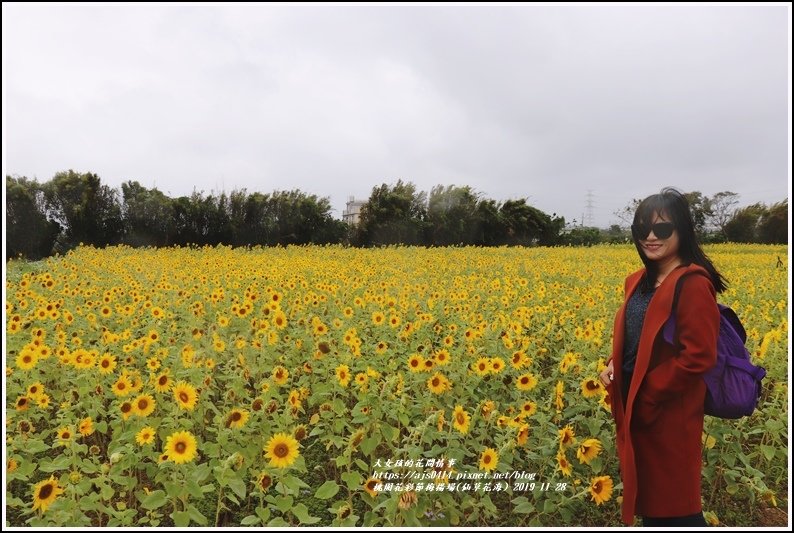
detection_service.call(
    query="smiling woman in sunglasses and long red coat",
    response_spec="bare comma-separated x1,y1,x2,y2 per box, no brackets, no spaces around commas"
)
601,188,726,526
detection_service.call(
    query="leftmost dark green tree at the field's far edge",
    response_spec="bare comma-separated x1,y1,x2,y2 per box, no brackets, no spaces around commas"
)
6,176,61,259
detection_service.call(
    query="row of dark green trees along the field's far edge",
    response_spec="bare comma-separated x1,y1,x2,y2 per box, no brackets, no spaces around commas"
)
6,170,788,259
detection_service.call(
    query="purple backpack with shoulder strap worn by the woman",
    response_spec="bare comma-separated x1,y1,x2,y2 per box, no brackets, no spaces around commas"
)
662,279,766,418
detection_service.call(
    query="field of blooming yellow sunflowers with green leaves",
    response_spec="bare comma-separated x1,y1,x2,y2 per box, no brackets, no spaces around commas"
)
5,245,789,527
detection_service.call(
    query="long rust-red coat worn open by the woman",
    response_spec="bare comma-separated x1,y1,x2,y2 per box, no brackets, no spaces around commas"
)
609,265,720,525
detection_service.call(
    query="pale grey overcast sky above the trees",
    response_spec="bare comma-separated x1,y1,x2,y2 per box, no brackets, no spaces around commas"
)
2,3,791,226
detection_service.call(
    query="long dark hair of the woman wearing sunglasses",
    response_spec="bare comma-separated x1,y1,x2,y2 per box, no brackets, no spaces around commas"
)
632,187,728,292
